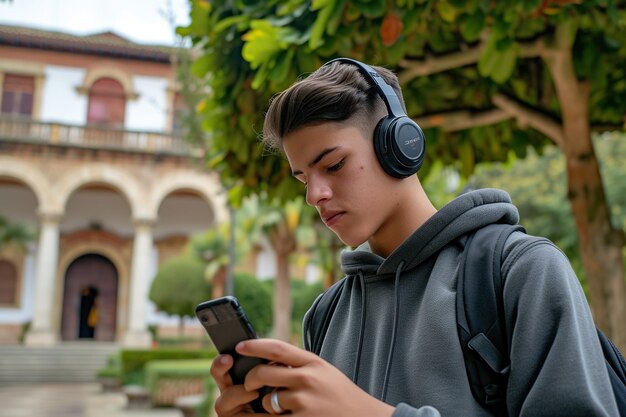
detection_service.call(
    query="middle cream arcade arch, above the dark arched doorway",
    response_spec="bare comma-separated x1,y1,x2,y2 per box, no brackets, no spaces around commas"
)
58,165,145,218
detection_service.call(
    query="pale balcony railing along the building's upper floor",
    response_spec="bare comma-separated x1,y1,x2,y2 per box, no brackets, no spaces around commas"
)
0,117,202,156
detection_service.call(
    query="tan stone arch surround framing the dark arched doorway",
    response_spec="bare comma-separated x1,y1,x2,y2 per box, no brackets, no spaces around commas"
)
54,241,130,340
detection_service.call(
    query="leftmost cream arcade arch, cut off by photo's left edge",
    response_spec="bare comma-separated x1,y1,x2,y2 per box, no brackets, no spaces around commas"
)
0,157,54,213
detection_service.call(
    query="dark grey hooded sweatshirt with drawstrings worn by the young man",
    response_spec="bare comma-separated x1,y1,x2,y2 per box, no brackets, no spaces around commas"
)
304,189,618,417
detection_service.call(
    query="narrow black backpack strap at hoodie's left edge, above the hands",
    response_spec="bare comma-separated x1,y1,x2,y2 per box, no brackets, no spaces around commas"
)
305,278,346,355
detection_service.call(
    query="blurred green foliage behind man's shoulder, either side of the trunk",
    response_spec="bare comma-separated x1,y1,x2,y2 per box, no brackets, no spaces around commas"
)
469,134,626,283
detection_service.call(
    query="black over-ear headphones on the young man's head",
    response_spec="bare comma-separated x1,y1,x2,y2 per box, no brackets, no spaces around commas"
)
324,58,426,178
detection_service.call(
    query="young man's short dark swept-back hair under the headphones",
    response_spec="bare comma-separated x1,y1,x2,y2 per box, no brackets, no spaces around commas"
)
263,62,404,151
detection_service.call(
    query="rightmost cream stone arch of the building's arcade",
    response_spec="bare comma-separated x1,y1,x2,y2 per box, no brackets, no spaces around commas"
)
149,170,228,224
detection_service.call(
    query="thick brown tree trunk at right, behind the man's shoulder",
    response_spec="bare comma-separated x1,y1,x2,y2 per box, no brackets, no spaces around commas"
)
545,25,626,351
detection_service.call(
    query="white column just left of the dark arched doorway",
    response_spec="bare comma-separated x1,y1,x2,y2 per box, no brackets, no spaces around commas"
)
25,213,61,345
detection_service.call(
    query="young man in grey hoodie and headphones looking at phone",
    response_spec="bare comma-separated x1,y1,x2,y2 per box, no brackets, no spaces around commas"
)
212,60,618,417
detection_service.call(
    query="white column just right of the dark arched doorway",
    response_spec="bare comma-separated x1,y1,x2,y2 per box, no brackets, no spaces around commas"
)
124,219,154,347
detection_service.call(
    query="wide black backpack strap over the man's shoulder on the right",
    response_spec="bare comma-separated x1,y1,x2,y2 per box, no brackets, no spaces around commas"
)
456,224,524,416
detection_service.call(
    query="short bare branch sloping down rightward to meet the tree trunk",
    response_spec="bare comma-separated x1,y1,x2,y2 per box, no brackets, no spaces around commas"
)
491,94,565,149
